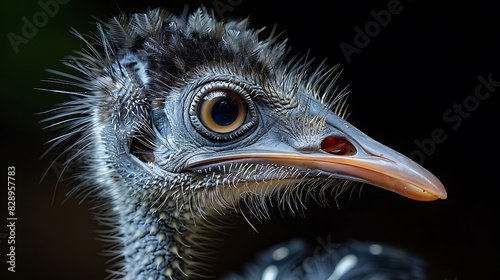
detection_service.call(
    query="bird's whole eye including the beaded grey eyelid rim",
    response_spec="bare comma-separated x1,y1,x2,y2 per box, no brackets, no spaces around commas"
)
189,82,257,141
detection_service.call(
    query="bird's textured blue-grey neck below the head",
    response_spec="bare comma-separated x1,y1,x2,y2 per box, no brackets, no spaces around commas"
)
117,189,223,280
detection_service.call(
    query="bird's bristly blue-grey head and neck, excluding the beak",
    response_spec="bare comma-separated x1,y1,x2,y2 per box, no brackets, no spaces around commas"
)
43,6,442,279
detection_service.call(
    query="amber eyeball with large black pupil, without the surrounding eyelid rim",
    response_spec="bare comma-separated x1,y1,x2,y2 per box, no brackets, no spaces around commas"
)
198,89,247,133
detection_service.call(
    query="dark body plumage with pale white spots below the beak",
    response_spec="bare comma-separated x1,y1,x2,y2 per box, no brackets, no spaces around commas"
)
223,239,425,280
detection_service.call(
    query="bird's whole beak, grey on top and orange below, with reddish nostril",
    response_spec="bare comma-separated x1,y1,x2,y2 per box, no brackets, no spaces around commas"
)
187,105,447,201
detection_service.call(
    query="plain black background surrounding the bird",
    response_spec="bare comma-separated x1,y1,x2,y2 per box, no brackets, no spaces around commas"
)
0,0,500,279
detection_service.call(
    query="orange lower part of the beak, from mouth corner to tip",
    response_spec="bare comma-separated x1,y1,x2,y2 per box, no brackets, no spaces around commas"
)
187,147,447,201
